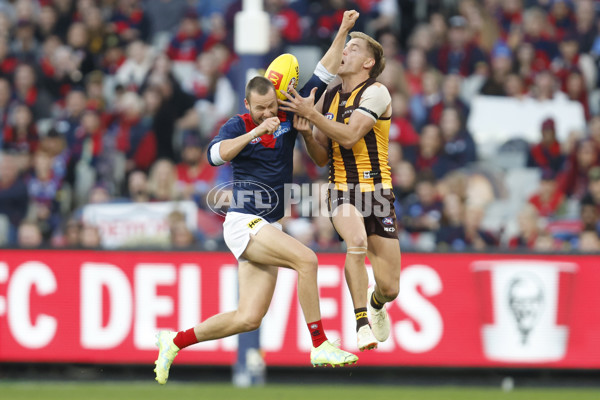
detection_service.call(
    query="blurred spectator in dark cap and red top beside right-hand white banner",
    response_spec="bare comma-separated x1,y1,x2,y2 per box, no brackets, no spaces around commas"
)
527,118,565,173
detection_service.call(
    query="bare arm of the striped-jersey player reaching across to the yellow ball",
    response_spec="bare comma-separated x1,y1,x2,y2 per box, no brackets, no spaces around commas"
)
281,89,376,149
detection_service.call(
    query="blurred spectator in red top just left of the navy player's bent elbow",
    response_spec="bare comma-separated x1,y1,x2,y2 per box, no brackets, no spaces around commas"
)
177,130,218,207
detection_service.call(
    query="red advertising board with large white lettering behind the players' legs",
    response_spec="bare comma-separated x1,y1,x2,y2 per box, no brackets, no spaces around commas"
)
0,250,600,368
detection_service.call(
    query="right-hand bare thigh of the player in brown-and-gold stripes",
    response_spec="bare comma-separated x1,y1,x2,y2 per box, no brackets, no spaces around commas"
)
368,235,400,295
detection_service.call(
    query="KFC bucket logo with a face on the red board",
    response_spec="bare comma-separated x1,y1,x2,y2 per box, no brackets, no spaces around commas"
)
472,260,577,362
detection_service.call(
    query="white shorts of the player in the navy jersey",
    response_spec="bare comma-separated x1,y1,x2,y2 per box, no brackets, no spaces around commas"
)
223,212,282,262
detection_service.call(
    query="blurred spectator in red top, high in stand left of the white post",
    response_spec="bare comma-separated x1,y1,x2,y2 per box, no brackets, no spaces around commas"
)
167,9,206,62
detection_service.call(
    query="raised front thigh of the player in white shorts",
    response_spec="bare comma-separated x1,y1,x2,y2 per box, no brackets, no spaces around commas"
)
243,225,317,269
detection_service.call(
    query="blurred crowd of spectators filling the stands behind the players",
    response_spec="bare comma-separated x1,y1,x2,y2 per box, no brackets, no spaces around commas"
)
0,0,600,252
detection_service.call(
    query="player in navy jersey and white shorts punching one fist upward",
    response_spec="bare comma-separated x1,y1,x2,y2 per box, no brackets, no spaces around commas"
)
155,10,358,384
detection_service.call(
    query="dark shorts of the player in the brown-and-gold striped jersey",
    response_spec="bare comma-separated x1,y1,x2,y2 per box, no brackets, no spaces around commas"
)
327,188,398,240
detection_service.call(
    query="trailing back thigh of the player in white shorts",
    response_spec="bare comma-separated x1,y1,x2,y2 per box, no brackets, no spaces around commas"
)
238,261,277,320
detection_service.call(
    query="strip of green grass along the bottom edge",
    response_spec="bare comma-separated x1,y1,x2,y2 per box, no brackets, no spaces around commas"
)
0,382,600,400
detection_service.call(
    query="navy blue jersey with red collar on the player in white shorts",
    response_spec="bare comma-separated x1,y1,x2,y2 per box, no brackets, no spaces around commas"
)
207,75,327,222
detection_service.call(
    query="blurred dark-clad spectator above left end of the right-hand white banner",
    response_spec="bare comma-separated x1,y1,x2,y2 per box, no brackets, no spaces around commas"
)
434,15,485,77
